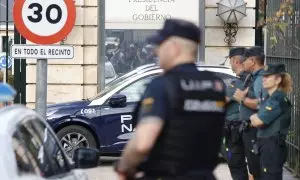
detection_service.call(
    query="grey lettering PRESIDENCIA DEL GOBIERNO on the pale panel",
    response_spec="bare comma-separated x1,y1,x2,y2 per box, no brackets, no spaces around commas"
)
129,0,175,21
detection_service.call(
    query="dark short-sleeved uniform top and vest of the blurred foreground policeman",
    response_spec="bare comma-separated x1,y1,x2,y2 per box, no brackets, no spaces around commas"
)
139,64,225,174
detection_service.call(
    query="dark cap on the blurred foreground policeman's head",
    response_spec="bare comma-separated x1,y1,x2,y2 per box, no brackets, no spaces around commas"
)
147,19,200,45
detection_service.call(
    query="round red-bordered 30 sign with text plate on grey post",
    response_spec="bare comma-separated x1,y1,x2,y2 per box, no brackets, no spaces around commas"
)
11,0,76,118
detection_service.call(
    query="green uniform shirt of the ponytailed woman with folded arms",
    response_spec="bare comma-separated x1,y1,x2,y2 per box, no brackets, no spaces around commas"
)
257,90,292,137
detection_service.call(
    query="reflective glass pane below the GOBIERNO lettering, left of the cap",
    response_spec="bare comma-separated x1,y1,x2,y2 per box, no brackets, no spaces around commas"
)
105,29,157,75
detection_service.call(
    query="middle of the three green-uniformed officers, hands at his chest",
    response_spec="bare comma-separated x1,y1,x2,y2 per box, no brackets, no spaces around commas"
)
234,46,267,180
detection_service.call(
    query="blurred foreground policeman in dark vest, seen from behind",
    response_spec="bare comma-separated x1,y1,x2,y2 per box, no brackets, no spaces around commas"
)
115,19,226,180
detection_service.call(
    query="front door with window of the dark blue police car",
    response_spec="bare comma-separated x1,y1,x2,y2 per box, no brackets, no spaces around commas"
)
101,75,155,153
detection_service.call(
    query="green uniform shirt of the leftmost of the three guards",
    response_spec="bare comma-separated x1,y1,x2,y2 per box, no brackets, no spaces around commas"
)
226,72,248,121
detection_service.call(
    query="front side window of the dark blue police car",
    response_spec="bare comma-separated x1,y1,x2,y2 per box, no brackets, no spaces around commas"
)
118,76,155,102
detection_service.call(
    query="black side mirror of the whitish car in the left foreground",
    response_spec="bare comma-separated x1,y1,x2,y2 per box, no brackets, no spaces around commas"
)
73,147,100,169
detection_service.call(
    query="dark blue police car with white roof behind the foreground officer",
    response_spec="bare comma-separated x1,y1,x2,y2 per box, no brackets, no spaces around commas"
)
47,64,235,156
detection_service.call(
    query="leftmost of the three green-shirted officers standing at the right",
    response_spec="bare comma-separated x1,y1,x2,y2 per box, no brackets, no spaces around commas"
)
223,47,249,180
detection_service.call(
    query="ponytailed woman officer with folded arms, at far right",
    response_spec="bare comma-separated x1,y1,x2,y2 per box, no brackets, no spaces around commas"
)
250,64,292,180
